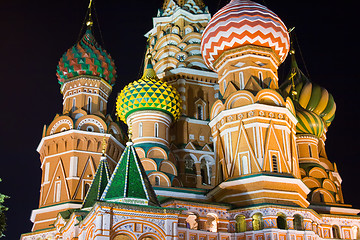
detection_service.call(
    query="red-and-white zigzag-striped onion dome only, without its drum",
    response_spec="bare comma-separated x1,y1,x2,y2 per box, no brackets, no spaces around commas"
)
201,0,290,69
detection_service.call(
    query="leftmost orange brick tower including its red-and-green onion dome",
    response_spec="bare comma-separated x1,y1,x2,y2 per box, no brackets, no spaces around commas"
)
31,12,124,231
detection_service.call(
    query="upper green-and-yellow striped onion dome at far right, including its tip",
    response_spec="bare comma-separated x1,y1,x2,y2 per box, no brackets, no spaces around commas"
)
280,54,336,127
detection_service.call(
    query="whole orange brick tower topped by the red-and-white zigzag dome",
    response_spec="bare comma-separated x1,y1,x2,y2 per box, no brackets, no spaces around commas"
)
201,0,309,207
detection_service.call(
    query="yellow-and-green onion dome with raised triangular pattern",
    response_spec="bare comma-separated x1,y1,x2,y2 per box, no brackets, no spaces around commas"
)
116,59,181,123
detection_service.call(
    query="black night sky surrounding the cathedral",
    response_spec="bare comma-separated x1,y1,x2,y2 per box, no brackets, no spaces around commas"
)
0,0,360,240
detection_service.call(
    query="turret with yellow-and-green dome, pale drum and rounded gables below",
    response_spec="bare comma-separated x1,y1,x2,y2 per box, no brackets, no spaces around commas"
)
116,54,181,186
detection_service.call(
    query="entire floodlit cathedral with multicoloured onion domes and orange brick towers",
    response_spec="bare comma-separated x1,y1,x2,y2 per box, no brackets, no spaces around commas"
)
21,0,360,240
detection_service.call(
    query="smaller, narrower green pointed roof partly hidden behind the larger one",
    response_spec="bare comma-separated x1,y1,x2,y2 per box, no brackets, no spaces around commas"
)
82,156,110,208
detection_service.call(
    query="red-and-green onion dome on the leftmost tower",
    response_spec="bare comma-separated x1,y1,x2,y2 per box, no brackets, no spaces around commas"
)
56,29,116,85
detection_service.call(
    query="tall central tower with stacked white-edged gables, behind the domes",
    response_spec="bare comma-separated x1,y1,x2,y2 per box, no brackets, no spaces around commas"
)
145,0,218,190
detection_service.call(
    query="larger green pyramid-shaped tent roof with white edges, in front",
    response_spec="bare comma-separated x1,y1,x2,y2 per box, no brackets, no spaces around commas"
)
101,142,160,206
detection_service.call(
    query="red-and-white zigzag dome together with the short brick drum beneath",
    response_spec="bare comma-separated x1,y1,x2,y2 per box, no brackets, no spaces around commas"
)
201,0,290,98
